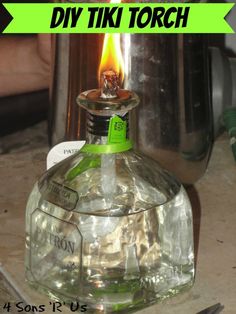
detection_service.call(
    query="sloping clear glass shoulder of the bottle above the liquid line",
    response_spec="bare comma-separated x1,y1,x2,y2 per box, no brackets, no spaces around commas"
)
38,150,181,215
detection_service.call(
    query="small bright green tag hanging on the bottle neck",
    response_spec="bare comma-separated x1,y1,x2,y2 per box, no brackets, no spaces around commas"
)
107,116,127,144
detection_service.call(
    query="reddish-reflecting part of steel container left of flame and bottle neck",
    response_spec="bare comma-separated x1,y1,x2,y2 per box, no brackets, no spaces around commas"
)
49,34,102,145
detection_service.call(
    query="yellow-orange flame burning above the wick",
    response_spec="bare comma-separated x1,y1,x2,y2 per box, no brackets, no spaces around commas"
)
98,0,124,83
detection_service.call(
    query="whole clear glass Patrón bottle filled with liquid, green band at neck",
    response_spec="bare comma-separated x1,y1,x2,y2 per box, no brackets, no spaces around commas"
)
26,82,194,313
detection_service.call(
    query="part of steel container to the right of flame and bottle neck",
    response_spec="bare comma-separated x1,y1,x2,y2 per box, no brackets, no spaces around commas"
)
125,35,212,183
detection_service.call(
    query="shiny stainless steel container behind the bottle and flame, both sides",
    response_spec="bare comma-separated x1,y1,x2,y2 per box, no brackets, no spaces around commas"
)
50,1,212,184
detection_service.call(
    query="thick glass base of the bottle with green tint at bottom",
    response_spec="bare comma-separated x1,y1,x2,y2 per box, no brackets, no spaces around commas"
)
28,272,194,314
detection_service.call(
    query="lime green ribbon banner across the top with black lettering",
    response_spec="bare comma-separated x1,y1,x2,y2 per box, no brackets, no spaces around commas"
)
0,3,234,33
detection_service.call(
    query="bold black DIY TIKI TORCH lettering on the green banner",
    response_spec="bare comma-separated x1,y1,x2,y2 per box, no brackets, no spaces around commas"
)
50,6,190,29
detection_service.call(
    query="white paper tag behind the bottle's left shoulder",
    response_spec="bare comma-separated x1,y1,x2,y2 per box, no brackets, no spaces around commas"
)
47,141,85,170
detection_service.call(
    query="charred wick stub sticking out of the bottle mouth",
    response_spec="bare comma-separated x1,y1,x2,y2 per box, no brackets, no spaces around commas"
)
101,70,120,99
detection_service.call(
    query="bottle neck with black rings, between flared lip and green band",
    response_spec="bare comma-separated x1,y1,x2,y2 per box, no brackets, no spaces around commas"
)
87,112,129,145
